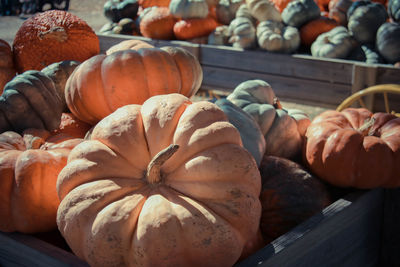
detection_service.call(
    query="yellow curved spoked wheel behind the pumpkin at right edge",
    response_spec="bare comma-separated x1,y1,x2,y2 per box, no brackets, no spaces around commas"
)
336,84,400,117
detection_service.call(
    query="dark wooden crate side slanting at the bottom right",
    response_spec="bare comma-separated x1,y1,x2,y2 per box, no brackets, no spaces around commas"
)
237,189,384,267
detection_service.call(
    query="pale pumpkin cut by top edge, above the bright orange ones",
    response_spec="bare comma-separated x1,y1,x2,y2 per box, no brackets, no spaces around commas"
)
169,0,208,19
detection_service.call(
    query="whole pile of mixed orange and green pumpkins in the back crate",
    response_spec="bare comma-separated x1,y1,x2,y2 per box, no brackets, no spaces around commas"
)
100,0,400,66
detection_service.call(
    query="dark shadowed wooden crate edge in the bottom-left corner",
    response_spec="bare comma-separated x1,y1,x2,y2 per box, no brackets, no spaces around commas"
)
0,232,88,267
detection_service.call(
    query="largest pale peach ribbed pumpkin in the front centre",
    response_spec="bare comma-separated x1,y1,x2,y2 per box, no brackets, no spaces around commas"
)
57,94,261,266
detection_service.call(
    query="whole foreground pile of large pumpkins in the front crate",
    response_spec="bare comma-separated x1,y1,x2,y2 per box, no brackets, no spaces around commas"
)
0,11,400,266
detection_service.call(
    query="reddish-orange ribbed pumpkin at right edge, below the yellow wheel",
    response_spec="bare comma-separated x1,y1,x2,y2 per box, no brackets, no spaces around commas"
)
305,108,400,188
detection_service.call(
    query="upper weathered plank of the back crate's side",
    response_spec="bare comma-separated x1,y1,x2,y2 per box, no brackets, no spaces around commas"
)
200,45,353,84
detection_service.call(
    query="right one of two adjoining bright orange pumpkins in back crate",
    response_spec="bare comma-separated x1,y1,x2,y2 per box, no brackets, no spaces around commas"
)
173,16,218,40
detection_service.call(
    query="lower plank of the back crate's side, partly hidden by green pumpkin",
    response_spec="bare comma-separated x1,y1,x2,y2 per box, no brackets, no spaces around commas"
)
202,65,350,109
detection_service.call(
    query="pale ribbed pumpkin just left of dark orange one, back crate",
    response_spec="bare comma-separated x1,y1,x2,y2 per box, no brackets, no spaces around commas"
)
256,20,300,54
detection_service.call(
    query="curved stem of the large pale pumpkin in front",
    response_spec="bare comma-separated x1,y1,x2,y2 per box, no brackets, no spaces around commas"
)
146,144,179,184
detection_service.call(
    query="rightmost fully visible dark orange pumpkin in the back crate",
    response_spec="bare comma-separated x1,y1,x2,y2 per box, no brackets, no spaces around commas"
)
299,16,339,46
